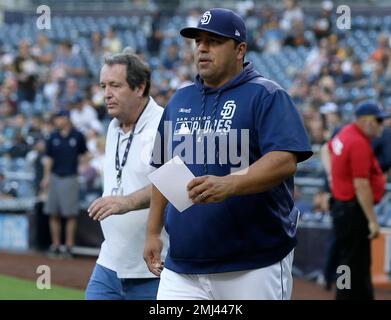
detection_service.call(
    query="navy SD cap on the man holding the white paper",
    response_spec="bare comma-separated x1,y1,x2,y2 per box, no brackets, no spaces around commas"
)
180,8,247,42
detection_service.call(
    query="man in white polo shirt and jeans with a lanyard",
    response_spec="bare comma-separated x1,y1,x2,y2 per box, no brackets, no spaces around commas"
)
86,54,167,300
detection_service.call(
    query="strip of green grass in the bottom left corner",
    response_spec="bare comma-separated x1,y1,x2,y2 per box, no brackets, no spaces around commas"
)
0,275,84,300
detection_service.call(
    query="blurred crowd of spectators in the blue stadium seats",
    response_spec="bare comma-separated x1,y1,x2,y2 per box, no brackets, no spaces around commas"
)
0,0,391,220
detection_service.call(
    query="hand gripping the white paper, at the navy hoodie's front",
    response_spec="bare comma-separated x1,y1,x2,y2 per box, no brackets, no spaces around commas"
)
187,175,235,203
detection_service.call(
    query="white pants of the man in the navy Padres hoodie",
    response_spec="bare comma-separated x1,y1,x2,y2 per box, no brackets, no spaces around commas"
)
157,250,293,300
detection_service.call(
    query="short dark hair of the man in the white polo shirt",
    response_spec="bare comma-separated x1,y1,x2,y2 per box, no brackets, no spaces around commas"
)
104,53,151,97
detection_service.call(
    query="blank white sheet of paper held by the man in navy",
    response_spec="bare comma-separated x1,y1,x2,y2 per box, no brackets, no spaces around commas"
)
148,156,195,212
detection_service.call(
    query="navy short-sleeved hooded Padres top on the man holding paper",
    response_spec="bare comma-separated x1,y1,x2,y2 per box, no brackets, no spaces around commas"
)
151,62,312,274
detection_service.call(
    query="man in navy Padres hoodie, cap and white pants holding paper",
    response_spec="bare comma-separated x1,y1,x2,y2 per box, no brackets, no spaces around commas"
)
144,8,312,299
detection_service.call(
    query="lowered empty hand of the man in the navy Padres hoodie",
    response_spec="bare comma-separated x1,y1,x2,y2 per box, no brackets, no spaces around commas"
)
144,235,164,277
